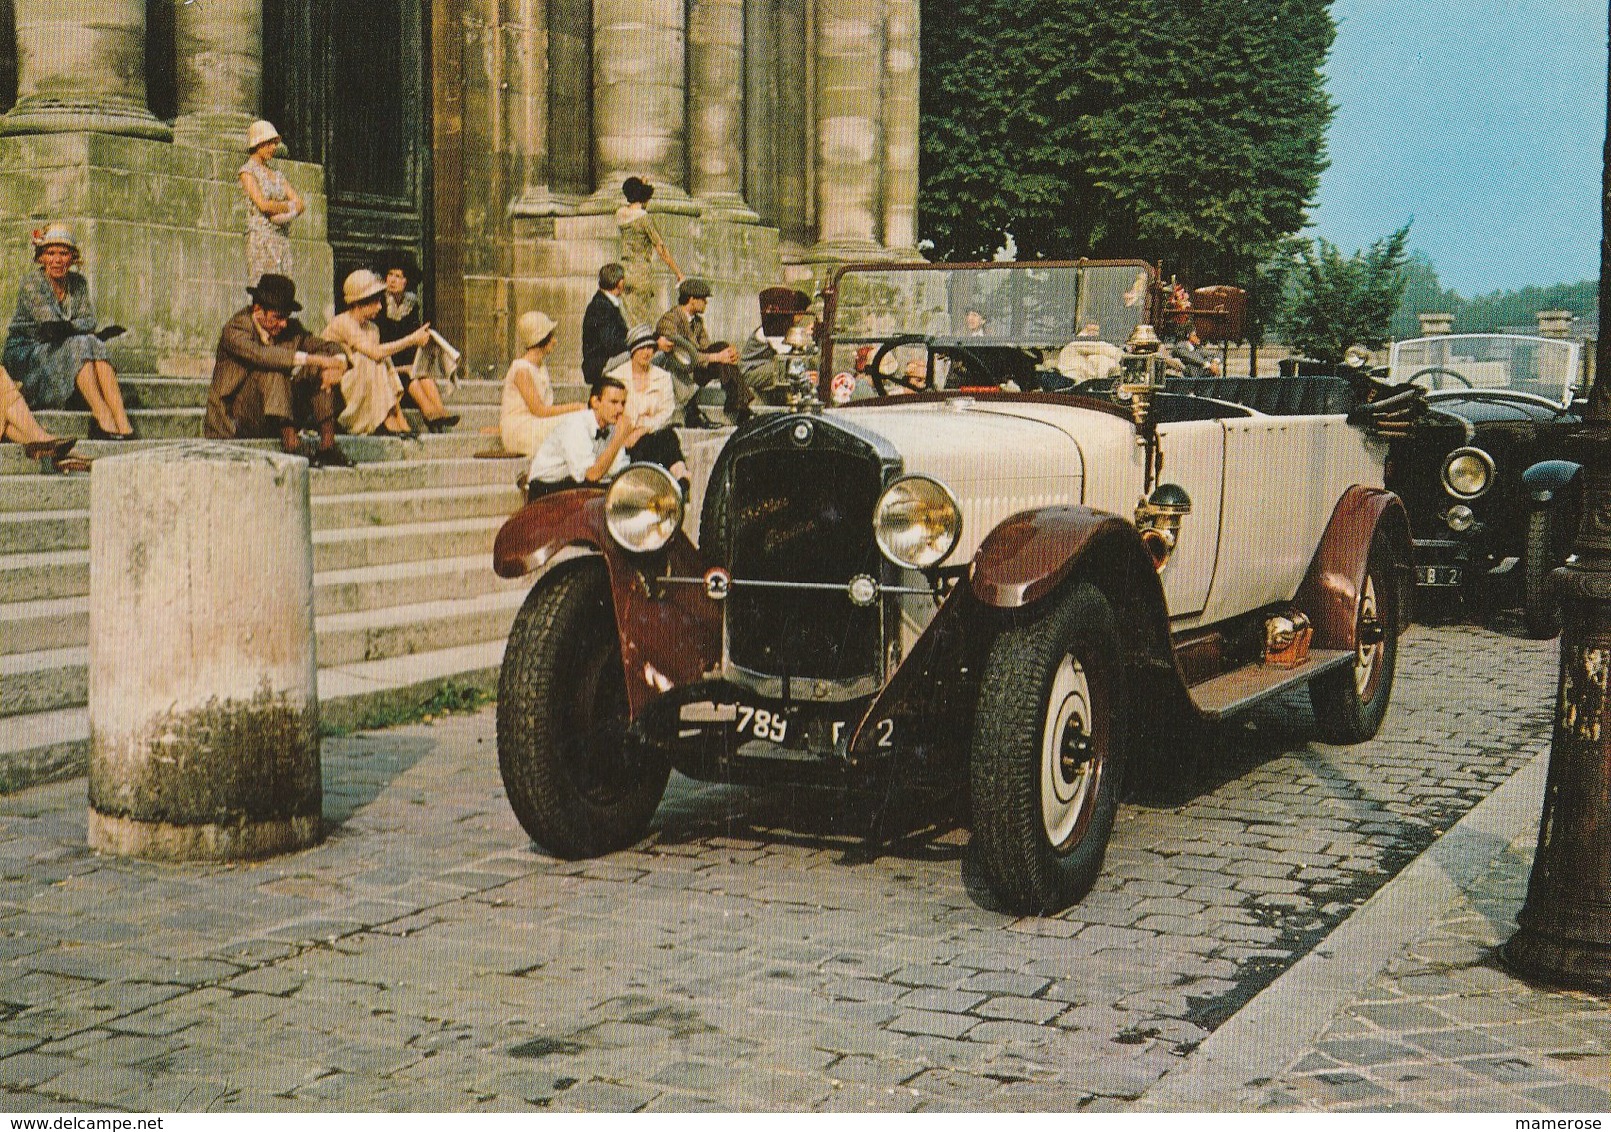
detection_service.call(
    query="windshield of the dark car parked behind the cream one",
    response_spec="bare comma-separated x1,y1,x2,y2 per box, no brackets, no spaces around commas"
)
1389,333,1582,407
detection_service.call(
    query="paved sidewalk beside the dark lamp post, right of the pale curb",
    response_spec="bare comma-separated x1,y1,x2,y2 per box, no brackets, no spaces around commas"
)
1257,836,1611,1113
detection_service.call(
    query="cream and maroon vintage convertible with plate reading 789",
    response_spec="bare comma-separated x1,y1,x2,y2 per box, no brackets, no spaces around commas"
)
493,261,1411,913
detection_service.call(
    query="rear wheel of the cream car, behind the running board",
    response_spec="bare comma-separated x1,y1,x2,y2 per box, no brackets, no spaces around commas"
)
1310,535,1398,744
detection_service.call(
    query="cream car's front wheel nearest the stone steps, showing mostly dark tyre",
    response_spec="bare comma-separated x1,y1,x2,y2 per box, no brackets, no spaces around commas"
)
498,560,670,858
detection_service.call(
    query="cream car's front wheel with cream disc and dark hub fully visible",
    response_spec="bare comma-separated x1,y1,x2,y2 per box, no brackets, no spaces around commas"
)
970,585,1129,915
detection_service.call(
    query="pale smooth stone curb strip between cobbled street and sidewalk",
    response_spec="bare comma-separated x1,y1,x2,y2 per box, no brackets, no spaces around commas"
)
1129,750,1550,1113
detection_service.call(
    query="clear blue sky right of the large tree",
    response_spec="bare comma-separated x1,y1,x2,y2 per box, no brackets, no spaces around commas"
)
1308,0,1606,296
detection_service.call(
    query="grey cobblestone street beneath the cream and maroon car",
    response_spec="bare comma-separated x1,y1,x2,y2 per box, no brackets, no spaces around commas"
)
0,626,1564,1111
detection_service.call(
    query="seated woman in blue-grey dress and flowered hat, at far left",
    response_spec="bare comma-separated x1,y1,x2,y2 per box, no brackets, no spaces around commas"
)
0,224,134,440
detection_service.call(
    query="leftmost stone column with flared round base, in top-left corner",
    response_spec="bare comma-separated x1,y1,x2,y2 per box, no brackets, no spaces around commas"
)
0,0,172,140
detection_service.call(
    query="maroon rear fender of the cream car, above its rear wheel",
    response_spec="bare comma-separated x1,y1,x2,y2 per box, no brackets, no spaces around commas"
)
1297,485,1410,649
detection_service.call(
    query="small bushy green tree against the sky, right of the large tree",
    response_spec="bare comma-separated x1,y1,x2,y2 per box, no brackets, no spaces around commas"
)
1279,224,1410,366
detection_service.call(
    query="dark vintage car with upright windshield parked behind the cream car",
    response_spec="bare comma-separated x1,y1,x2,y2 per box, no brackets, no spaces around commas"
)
1387,333,1587,638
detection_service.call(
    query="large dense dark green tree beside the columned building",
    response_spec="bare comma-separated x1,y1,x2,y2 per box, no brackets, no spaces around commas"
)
920,0,1334,301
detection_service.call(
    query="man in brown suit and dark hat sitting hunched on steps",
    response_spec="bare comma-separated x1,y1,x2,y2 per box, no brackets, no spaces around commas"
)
203,272,353,467
